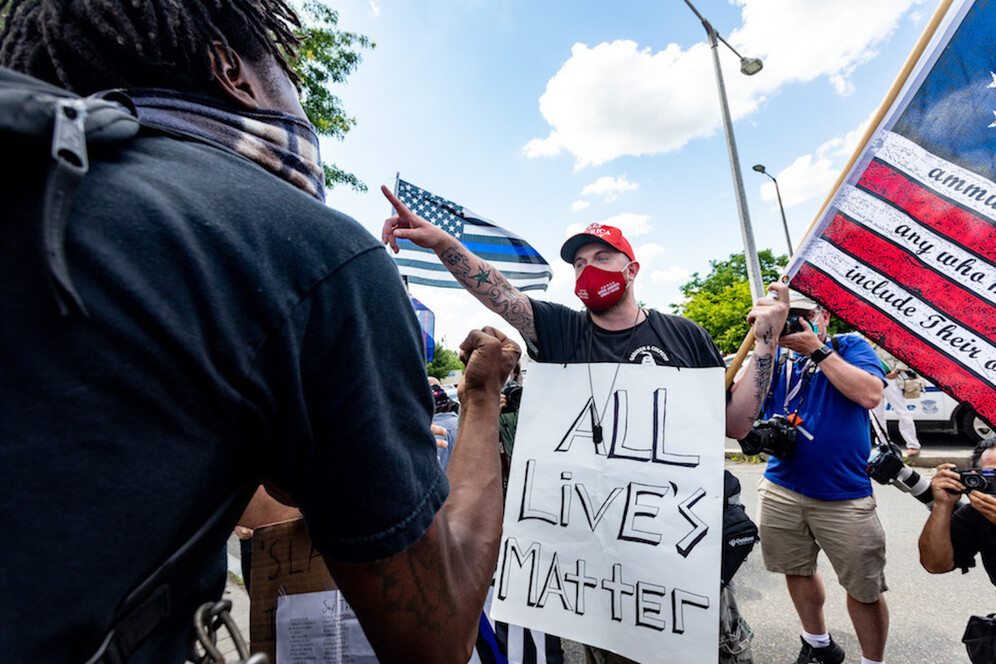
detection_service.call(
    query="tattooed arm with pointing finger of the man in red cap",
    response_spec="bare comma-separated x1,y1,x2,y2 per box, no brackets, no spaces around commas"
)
380,185,536,343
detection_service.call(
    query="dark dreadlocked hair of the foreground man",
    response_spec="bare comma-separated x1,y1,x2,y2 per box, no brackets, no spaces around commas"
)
0,0,301,95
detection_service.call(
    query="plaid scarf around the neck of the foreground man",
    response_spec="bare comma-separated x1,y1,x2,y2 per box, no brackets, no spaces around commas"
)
127,89,325,202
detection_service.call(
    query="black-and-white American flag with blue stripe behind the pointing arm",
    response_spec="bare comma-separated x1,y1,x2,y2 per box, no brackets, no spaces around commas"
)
394,179,553,291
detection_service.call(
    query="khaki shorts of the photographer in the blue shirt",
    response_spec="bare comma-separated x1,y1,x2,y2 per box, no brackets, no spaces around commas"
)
757,478,887,604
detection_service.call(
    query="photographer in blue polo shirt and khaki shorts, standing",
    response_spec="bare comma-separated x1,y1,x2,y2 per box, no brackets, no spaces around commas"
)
741,291,889,664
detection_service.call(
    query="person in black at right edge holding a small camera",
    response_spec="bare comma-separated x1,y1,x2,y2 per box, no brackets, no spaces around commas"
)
920,437,996,585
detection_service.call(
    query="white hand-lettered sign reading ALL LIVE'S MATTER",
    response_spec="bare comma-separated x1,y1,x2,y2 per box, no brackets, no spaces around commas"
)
491,364,725,663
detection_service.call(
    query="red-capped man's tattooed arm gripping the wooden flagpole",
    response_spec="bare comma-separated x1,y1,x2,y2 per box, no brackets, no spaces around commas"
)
726,283,789,440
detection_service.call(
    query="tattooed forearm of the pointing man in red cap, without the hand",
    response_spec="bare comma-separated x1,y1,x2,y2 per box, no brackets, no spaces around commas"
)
439,245,536,341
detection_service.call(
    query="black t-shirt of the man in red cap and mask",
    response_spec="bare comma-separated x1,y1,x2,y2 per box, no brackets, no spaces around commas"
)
529,300,724,367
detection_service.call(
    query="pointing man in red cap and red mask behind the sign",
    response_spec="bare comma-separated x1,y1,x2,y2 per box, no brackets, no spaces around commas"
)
382,188,788,662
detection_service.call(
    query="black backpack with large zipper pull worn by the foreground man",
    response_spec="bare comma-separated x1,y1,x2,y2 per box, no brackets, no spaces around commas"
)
0,67,258,664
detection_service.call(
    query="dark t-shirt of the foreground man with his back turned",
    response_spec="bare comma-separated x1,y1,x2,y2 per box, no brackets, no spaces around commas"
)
0,136,448,662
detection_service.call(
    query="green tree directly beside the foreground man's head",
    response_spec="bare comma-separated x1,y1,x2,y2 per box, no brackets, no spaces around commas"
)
294,0,376,191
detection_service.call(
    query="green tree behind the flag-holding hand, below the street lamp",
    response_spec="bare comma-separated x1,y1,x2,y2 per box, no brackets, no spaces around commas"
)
671,249,788,353
